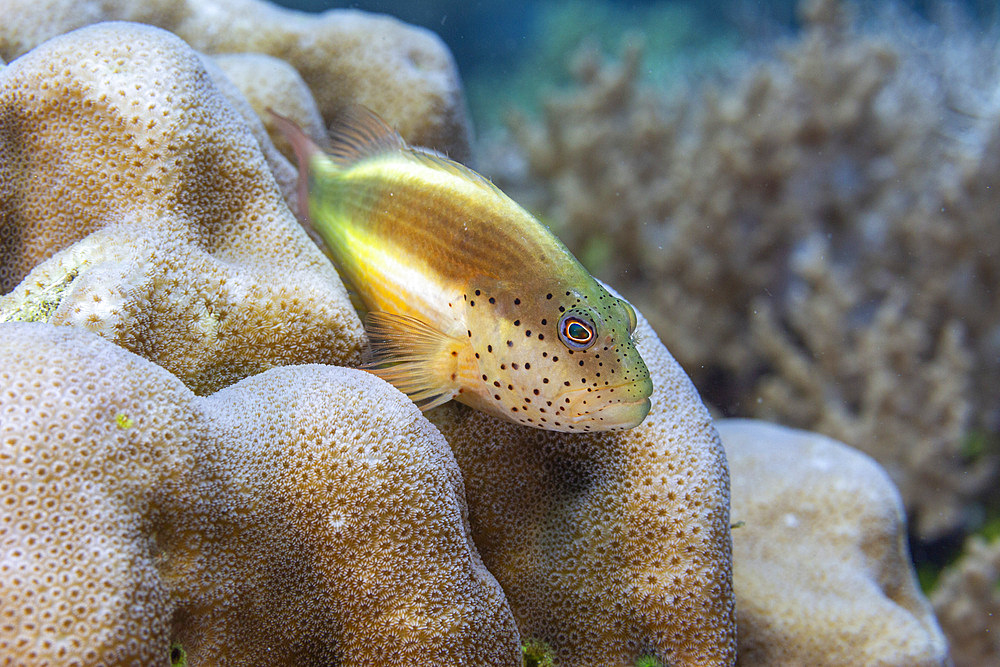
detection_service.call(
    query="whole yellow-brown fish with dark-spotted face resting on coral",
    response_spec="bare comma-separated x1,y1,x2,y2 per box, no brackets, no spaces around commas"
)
269,106,653,432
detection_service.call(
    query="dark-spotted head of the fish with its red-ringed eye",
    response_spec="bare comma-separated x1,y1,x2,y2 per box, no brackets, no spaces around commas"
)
459,281,653,432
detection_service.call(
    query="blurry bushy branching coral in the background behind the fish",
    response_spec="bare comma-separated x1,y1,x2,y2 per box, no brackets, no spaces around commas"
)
508,0,1000,538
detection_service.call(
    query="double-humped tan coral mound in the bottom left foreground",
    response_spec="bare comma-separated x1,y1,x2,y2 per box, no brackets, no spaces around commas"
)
0,323,521,667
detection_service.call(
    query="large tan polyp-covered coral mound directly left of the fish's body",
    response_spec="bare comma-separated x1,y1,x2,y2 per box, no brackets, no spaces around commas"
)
0,23,363,393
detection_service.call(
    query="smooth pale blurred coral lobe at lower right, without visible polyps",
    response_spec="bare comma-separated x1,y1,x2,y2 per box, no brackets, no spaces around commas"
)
717,419,949,667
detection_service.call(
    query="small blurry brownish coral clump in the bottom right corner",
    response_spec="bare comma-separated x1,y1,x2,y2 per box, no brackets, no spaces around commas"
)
931,537,1000,667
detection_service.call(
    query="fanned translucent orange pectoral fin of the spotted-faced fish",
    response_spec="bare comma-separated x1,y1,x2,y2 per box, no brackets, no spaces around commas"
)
362,312,470,410
